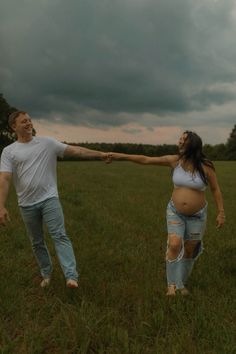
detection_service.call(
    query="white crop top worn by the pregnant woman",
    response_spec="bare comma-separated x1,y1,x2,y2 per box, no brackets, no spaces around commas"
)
172,164,207,191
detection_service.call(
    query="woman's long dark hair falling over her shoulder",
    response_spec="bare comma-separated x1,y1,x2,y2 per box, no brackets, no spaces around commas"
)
179,130,215,185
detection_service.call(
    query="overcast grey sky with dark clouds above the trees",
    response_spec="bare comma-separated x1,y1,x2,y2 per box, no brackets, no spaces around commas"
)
0,0,236,144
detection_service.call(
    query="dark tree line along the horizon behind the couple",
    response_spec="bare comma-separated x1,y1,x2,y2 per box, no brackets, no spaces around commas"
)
0,94,236,161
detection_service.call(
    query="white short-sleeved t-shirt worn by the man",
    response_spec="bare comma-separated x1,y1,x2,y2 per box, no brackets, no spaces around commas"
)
0,137,68,206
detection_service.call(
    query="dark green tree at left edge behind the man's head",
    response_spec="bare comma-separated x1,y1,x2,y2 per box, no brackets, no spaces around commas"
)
0,93,17,150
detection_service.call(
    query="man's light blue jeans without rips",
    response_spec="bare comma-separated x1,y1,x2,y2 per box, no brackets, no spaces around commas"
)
20,197,78,280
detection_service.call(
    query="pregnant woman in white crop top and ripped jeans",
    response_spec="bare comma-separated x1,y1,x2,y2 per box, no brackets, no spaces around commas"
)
109,131,225,296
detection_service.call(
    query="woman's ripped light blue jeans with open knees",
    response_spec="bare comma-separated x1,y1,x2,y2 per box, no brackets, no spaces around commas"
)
166,200,207,289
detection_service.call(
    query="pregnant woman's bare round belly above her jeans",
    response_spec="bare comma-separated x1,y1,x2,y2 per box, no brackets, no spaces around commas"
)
171,187,206,215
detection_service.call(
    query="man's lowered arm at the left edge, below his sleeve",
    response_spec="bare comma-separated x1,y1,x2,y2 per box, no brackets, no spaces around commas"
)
0,172,12,225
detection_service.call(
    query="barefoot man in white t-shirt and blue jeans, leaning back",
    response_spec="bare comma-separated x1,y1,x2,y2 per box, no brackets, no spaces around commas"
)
0,111,107,288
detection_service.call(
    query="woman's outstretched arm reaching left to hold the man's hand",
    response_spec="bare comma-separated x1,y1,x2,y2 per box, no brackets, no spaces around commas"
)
109,152,179,167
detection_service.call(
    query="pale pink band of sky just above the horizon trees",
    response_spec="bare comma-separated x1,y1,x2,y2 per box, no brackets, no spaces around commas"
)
33,119,230,145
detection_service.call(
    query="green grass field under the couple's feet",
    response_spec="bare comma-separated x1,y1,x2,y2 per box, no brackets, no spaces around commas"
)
0,162,236,354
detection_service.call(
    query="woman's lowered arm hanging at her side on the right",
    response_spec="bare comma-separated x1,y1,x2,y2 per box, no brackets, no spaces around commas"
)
205,166,225,228
